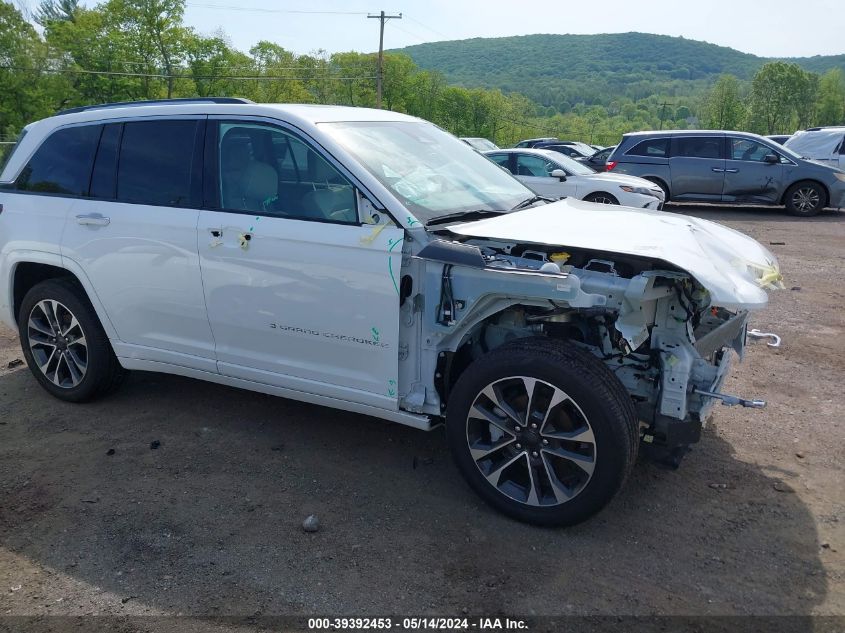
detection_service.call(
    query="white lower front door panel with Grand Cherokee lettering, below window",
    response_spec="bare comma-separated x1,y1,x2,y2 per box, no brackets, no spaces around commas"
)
198,211,403,410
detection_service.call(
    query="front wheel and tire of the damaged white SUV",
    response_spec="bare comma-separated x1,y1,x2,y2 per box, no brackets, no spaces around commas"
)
446,337,639,526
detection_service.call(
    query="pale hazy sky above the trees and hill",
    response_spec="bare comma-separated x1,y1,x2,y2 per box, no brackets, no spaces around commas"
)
166,0,845,57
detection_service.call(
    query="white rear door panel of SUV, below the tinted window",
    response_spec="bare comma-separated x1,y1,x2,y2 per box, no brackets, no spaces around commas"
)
62,199,214,367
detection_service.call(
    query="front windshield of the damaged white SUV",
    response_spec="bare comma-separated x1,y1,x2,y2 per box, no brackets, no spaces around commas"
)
320,121,534,224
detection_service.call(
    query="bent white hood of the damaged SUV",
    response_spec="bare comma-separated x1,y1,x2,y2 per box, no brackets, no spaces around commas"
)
449,198,781,310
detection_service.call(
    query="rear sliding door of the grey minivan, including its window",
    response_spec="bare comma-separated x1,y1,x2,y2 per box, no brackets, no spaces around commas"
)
669,135,725,201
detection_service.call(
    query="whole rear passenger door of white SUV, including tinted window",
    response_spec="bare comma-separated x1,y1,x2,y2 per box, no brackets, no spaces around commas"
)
62,117,216,371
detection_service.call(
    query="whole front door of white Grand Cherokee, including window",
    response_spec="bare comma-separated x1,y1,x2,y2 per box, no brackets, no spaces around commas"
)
198,120,404,410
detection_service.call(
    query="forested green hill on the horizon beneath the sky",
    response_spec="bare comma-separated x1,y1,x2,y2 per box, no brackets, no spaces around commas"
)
394,33,845,112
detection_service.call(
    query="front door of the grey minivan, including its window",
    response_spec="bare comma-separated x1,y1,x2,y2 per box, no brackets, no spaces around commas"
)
722,136,783,204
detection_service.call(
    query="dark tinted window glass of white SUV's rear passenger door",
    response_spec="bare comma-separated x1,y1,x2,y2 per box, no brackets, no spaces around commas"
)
117,119,202,206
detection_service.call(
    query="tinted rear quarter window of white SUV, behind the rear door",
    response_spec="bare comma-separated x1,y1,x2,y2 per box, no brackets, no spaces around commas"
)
15,125,102,196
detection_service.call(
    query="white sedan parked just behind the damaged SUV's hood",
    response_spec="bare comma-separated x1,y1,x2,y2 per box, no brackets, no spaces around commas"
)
484,149,664,209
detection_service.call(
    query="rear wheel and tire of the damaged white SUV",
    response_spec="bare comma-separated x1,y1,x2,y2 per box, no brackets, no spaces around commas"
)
18,279,126,402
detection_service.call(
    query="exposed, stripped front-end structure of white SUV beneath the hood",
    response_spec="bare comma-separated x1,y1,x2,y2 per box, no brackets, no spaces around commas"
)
400,207,779,465
